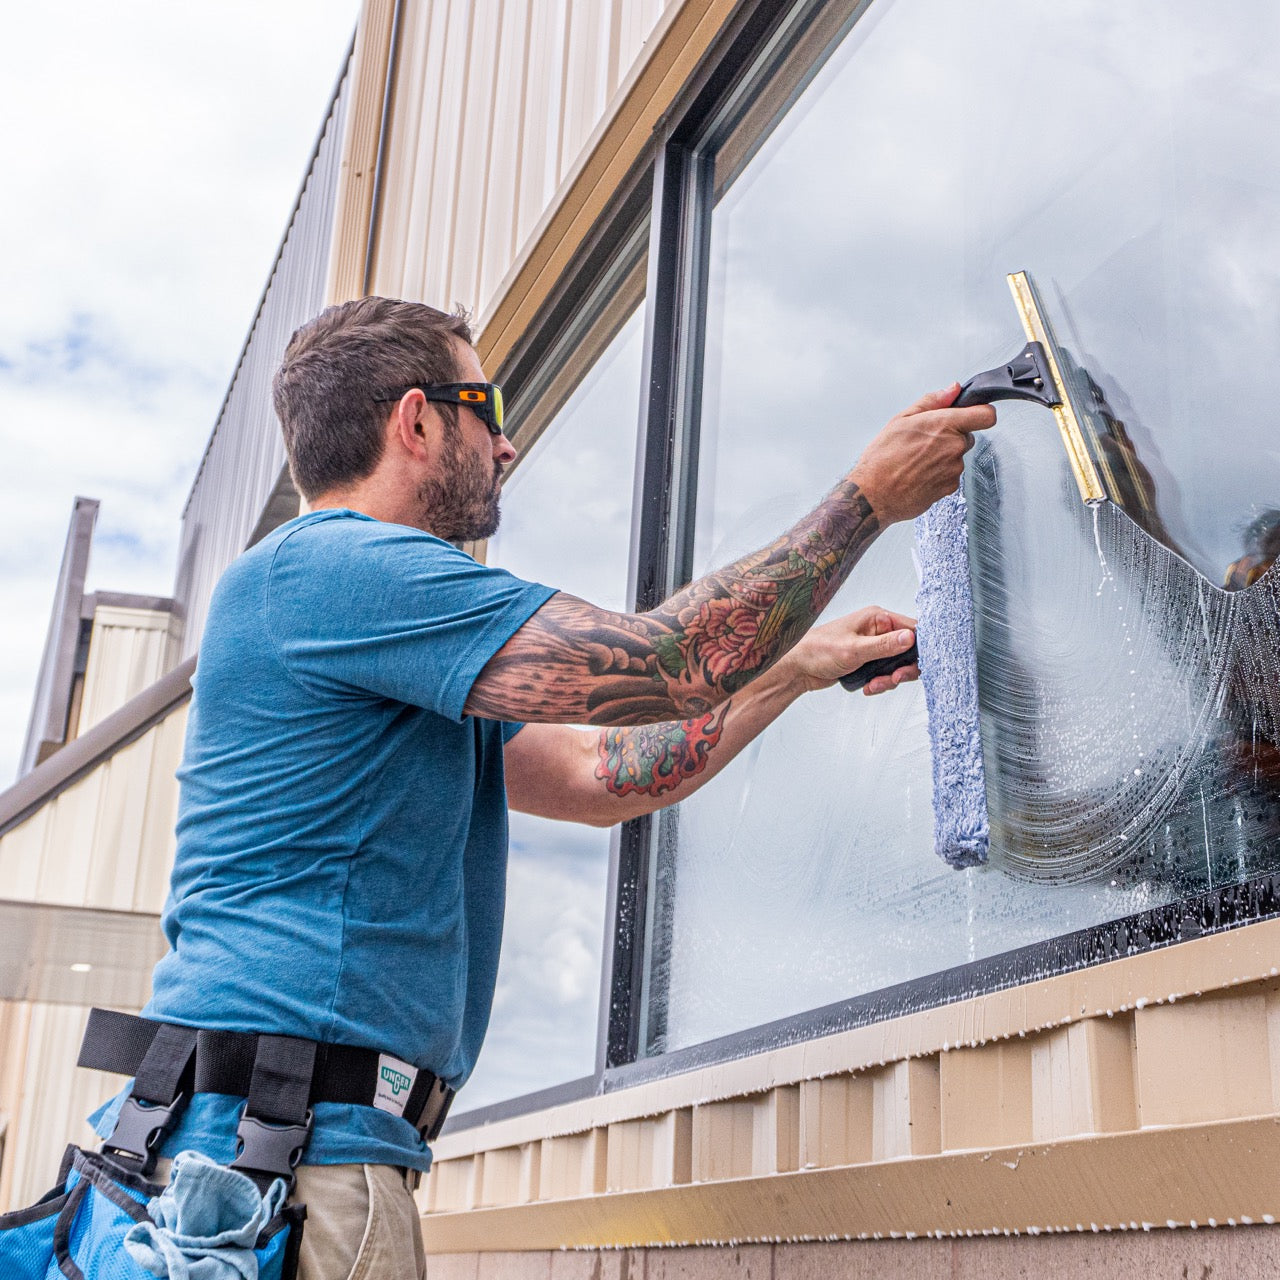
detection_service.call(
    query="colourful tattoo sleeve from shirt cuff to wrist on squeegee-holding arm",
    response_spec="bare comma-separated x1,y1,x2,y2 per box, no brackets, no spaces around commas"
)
466,477,879,724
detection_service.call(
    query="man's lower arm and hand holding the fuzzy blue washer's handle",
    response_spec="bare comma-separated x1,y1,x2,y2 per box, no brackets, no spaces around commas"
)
506,608,916,827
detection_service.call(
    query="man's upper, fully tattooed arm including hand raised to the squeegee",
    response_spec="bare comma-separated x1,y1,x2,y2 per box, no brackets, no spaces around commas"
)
466,385,995,724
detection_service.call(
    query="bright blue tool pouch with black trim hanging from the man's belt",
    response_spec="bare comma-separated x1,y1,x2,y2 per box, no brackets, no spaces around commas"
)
0,1147,306,1280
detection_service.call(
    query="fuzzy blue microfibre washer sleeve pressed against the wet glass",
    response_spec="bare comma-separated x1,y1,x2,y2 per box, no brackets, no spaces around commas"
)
915,493,991,867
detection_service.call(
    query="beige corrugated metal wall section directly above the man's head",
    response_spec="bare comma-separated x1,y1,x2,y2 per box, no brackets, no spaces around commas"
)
371,0,681,323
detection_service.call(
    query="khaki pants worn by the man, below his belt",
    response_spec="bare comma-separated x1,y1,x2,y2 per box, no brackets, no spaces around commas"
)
152,1160,426,1280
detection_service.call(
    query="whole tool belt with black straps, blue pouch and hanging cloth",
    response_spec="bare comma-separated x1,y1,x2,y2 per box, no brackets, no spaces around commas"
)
0,1009,453,1280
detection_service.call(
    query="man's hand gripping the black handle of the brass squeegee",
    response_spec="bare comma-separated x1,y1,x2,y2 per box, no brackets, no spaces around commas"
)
852,383,996,527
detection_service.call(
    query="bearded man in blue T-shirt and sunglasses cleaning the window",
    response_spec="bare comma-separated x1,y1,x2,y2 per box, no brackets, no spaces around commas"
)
92,298,995,1280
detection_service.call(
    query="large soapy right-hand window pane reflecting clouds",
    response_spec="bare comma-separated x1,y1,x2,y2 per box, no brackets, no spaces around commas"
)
645,0,1280,1052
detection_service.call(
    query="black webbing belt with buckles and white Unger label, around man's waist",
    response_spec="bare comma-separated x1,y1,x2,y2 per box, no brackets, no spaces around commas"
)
78,1009,454,1176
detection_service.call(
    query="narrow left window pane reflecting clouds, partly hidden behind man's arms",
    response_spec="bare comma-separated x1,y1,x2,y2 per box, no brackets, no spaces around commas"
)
462,311,643,1107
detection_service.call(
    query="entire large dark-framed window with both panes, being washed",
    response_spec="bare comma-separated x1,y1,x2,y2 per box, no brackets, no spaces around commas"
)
440,0,1280,1123
